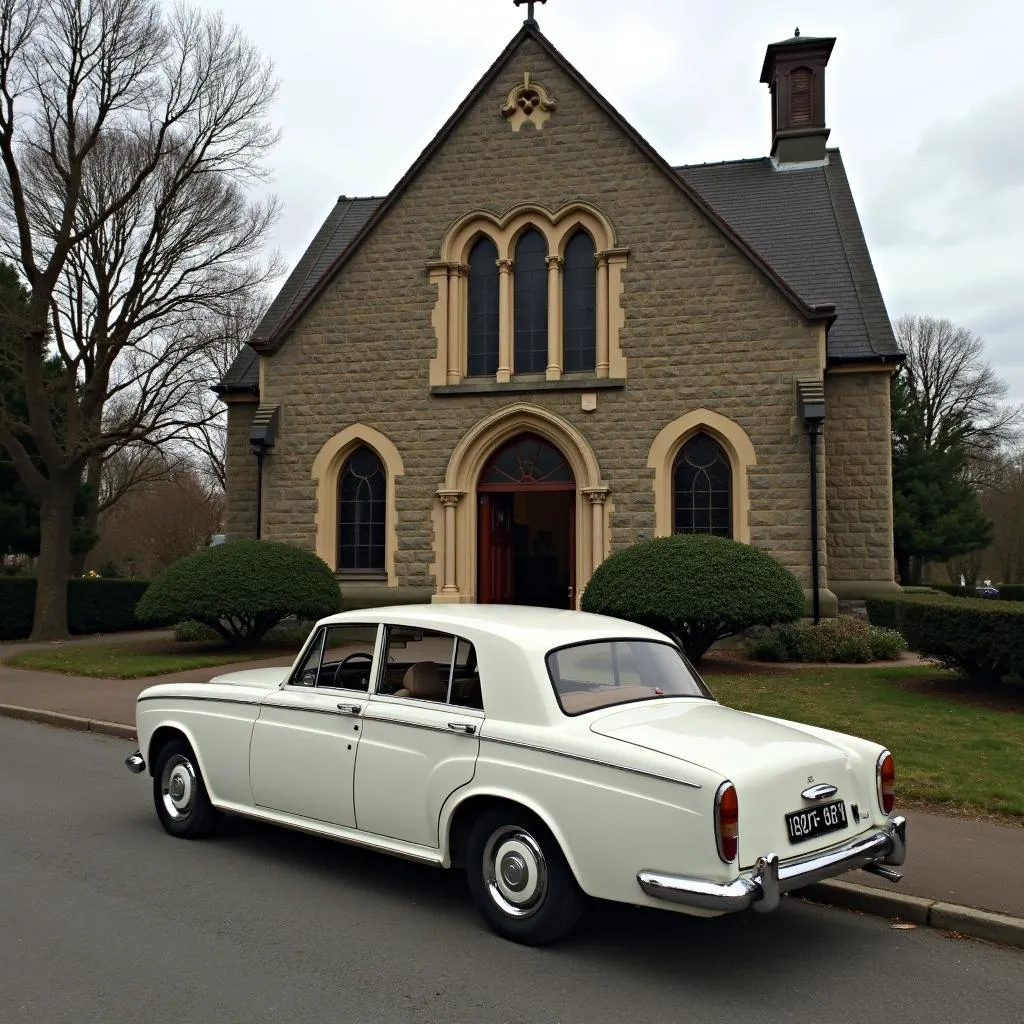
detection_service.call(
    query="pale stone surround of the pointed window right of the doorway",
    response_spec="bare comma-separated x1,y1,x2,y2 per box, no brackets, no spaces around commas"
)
647,409,758,544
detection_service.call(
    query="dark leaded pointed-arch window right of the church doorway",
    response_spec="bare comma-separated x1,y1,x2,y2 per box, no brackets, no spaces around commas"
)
672,431,732,537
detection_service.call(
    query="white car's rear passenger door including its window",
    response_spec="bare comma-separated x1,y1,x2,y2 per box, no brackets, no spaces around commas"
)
355,626,483,848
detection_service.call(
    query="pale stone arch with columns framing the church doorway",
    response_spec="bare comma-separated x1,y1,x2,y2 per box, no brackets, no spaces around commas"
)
431,402,612,607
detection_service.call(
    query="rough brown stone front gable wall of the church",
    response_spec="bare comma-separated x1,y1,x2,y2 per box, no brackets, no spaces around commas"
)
261,40,825,588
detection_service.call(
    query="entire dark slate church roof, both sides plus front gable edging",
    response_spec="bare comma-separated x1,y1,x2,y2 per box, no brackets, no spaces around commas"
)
215,24,901,394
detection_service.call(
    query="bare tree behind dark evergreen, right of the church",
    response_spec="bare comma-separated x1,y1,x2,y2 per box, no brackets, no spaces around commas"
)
895,316,1024,482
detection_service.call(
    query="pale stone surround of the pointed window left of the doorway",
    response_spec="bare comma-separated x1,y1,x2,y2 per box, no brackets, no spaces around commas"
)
310,423,406,587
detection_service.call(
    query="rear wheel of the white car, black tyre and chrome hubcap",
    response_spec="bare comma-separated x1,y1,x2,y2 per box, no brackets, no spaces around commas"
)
466,806,587,945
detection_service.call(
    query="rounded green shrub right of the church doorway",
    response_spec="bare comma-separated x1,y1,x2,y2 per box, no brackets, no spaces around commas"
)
581,534,805,660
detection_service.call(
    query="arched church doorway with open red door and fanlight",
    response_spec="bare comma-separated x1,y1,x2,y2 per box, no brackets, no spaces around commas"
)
476,433,577,608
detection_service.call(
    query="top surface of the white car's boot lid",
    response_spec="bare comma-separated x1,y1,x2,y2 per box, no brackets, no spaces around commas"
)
590,699,849,784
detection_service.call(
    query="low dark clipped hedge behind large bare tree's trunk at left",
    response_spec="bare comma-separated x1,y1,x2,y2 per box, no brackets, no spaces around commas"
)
0,577,150,640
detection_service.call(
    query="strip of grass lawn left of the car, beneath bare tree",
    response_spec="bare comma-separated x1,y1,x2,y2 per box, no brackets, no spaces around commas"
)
4,640,299,679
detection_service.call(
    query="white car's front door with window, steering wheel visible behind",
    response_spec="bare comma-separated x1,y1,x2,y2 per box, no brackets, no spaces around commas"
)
249,623,380,828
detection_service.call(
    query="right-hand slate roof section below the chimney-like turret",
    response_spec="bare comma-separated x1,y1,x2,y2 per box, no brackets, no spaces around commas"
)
676,150,900,361
